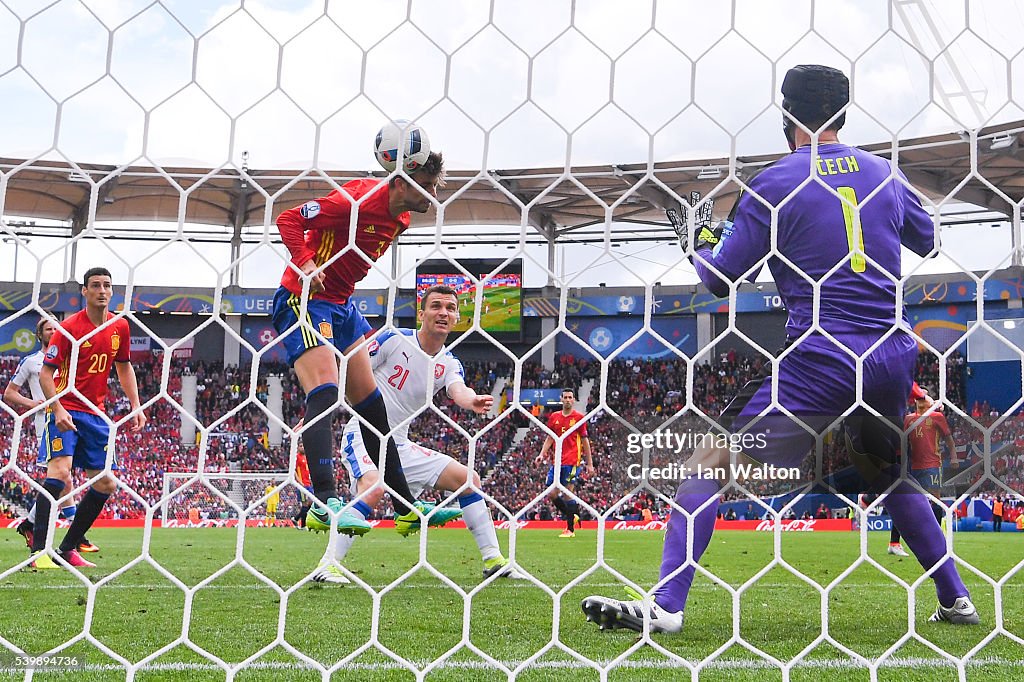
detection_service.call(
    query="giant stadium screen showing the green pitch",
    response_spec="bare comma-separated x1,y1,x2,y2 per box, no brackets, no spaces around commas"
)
416,259,522,334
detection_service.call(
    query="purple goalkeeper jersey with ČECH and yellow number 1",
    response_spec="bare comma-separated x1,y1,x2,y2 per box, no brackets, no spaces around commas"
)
694,143,935,337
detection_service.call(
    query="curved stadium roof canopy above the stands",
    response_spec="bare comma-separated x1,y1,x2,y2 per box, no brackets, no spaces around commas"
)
0,121,1024,243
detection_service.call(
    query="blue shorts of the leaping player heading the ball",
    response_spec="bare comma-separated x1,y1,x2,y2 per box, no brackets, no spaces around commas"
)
272,287,372,365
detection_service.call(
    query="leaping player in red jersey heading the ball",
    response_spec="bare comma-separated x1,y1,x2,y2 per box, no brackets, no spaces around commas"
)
273,152,456,535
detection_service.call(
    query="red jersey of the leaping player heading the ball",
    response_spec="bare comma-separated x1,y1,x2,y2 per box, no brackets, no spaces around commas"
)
278,178,410,303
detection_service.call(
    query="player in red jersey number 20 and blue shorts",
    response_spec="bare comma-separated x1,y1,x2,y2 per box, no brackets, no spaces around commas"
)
32,267,145,568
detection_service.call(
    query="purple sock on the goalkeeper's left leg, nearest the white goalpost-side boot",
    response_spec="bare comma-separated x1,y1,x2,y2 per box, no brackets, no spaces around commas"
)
654,478,719,612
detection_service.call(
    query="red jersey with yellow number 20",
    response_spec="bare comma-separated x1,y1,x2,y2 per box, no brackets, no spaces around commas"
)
43,310,131,415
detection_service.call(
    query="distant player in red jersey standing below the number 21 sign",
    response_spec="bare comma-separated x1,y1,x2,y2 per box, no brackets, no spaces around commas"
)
537,388,594,538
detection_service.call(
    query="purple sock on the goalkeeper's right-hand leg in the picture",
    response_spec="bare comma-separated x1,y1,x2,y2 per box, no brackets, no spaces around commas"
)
886,483,969,606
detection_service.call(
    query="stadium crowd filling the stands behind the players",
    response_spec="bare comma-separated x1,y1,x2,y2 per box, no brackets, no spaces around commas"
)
0,350,1024,518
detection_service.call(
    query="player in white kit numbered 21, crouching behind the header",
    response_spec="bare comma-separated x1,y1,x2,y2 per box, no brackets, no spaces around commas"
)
312,285,524,583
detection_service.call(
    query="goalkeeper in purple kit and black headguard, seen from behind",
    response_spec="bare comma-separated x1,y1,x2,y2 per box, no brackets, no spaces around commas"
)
582,66,979,632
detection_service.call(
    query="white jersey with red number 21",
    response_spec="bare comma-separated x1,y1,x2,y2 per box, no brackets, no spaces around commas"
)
345,329,466,444
